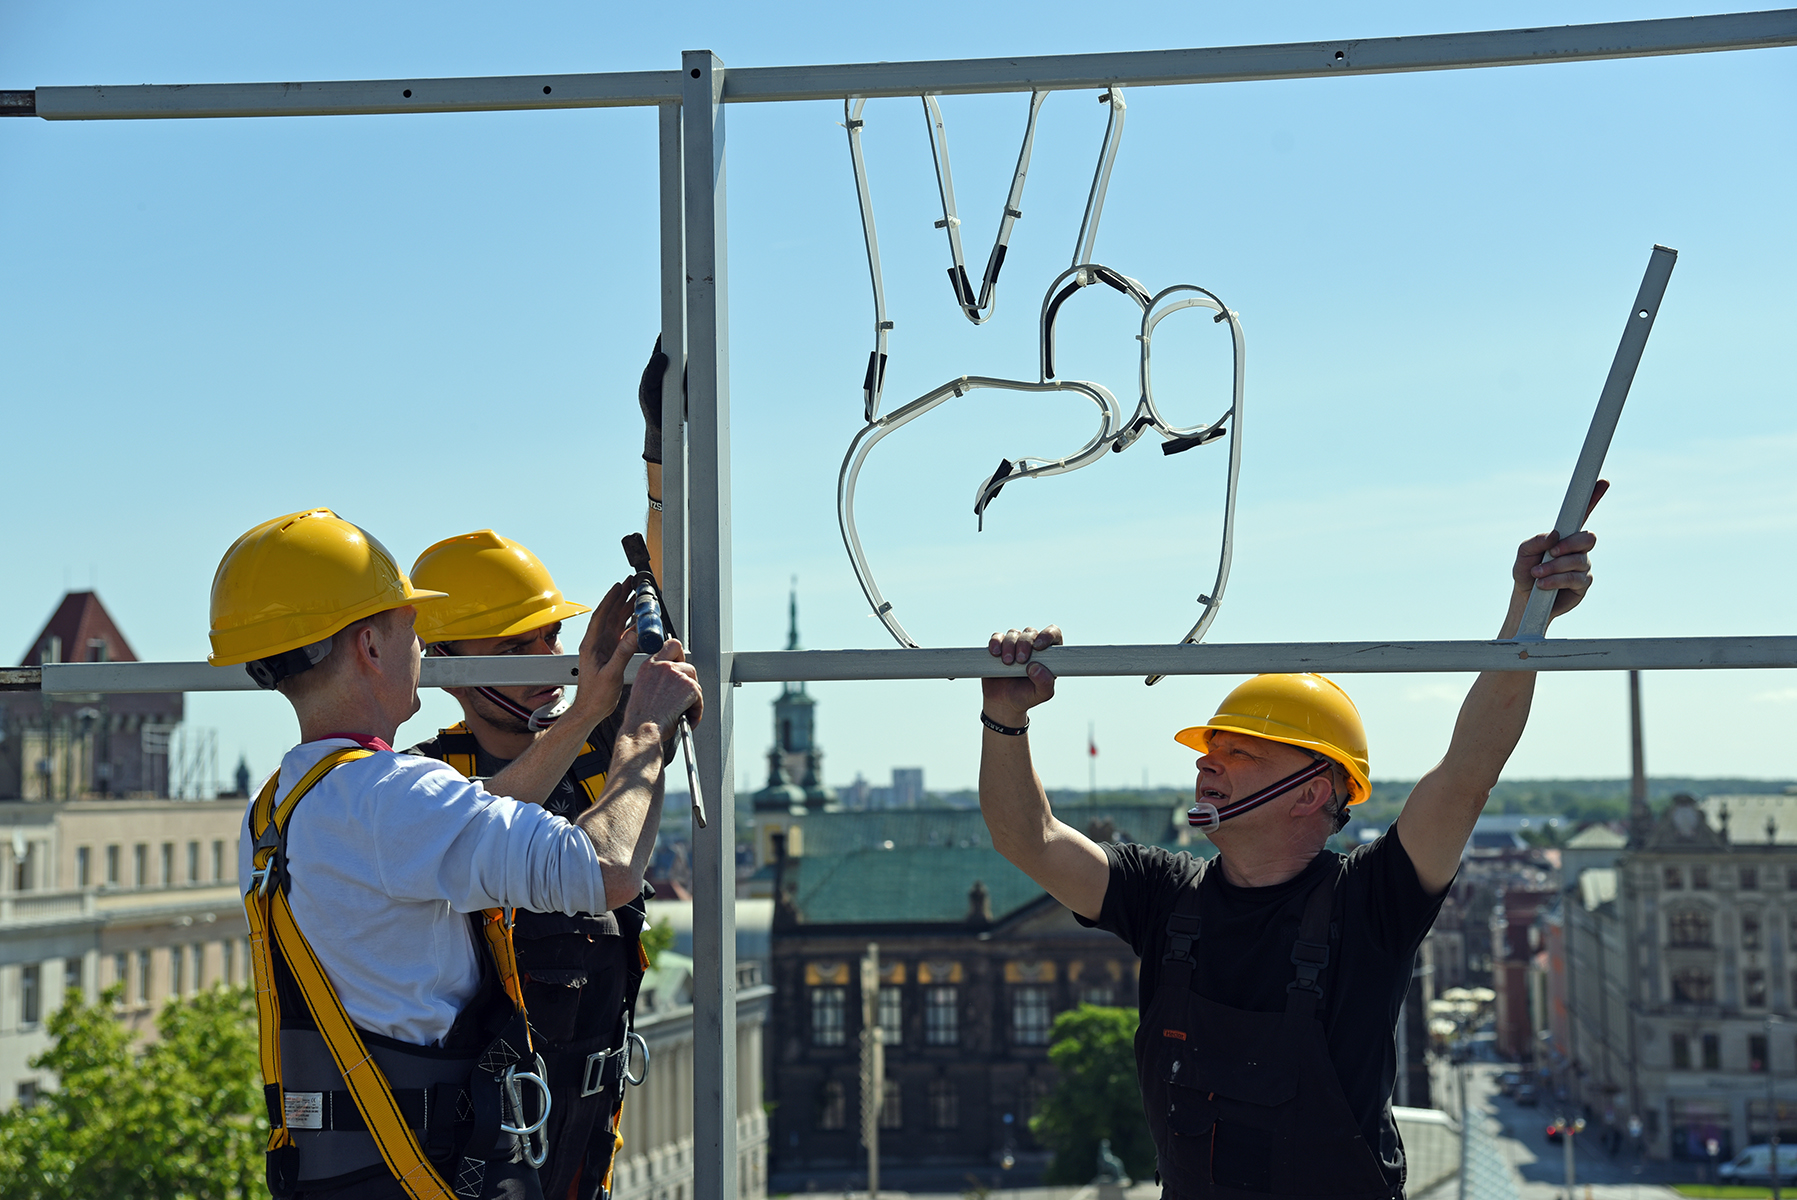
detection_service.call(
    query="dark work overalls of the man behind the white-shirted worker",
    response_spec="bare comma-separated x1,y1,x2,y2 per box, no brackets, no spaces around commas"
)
435,724,649,1200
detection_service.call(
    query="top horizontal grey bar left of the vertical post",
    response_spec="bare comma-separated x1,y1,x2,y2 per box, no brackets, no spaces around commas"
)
38,70,681,120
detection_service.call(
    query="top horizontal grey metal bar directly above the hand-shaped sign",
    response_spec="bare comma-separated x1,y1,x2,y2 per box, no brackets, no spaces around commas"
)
724,9,1797,102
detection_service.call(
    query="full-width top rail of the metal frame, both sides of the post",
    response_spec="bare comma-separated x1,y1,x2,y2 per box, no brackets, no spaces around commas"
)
17,9,1797,120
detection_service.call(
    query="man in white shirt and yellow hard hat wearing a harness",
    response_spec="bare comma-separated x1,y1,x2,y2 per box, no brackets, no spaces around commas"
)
210,508,703,1200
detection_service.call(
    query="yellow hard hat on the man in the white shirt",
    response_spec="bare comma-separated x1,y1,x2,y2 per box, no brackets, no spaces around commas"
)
207,508,444,666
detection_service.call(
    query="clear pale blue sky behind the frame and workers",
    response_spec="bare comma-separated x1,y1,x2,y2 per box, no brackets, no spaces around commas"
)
0,0,1797,787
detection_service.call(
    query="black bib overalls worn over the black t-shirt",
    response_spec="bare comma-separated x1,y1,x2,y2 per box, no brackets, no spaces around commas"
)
1136,858,1402,1200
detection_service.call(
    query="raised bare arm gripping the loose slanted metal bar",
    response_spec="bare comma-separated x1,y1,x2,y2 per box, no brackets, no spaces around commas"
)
1398,510,1605,896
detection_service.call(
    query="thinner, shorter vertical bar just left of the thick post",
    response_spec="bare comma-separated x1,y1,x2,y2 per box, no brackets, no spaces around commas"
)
658,104,688,634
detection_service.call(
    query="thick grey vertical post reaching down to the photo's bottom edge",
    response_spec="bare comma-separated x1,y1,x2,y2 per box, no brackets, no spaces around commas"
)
681,50,737,1200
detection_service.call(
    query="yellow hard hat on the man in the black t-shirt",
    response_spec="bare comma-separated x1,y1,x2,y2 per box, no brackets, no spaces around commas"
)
1173,675,1373,805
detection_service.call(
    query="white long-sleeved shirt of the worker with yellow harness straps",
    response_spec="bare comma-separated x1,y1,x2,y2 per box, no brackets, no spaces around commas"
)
237,738,606,1046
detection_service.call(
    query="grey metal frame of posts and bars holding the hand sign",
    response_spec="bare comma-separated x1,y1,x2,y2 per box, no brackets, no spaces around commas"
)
0,9,1797,1200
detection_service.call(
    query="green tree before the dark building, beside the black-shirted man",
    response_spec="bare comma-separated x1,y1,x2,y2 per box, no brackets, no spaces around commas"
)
1030,1004,1154,1184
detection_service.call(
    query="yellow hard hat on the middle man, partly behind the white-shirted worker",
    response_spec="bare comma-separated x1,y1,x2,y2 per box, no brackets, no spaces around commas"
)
412,530,593,645
